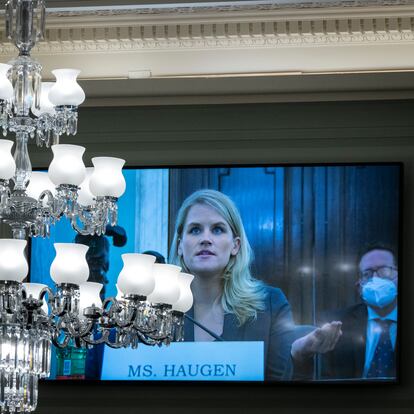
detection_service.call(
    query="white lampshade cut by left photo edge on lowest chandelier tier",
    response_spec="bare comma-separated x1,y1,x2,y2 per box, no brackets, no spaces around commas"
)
0,239,29,282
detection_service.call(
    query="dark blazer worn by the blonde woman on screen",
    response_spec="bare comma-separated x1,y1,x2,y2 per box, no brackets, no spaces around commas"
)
184,286,294,380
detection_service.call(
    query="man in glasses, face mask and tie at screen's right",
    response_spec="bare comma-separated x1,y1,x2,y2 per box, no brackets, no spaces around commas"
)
322,247,398,379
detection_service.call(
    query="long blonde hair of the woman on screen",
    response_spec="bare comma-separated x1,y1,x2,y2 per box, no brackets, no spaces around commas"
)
170,189,265,325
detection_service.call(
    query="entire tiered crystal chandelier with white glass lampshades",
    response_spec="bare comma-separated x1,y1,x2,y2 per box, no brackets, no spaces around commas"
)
0,0,193,413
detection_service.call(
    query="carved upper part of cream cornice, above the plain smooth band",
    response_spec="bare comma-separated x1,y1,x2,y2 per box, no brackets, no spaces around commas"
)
0,0,414,55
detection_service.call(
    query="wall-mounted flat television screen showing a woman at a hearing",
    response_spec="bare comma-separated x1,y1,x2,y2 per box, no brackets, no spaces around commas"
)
30,163,402,383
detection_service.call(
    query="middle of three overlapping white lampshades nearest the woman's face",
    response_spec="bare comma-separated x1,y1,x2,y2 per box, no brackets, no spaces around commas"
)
147,263,181,305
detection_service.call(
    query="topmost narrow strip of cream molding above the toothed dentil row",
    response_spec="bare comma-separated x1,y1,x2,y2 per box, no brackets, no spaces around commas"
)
41,0,414,24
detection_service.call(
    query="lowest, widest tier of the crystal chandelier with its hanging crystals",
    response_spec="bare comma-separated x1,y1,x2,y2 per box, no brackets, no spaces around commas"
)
0,239,193,413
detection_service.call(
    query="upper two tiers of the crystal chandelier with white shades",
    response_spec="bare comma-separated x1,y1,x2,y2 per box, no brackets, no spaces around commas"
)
0,0,125,239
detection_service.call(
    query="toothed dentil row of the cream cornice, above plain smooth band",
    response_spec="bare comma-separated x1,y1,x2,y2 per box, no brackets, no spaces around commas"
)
0,13,414,55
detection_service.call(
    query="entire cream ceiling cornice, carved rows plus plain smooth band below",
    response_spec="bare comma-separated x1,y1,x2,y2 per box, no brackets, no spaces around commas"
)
0,0,414,101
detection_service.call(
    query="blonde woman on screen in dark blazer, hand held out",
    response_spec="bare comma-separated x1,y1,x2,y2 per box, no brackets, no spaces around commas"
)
170,190,340,380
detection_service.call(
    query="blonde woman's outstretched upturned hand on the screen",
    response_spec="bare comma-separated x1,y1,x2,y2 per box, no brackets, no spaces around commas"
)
291,321,342,361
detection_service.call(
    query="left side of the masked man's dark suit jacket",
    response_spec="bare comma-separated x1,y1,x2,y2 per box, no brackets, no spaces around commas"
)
321,303,368,379
